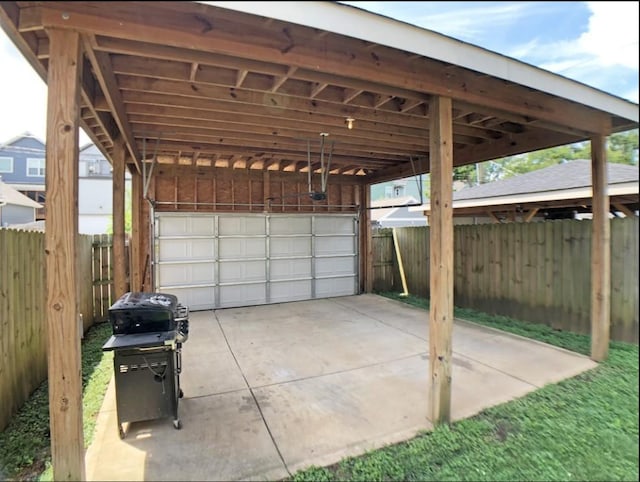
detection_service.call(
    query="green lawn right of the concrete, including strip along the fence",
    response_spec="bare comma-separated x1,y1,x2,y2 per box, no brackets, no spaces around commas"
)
292,294,639,481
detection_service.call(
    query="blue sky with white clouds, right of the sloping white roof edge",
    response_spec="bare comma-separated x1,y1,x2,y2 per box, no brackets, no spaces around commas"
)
341,2,639,103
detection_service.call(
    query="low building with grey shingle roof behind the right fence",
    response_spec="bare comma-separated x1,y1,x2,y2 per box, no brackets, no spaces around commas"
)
410,160,639,224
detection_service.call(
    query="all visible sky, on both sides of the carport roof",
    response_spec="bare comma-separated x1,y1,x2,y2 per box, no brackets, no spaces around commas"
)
0,1,640,143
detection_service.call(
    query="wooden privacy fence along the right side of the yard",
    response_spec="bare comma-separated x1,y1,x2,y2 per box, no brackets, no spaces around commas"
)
373,217,639,343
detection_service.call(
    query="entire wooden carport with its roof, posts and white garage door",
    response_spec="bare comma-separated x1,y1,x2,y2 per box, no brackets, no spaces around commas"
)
0,2,638,480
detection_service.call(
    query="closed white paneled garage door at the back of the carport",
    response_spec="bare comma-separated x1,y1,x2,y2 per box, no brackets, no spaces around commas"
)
154,213,358,311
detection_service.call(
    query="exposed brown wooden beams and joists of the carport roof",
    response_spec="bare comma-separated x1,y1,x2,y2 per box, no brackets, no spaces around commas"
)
0,2,637,183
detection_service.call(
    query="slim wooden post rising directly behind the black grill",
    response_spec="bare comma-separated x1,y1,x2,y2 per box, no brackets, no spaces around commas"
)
111,138,127,300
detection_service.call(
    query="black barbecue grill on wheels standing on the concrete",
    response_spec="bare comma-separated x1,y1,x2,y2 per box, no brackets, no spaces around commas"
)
102,292,189,438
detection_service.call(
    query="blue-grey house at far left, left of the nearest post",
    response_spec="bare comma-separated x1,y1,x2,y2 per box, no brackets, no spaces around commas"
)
0,132,45,219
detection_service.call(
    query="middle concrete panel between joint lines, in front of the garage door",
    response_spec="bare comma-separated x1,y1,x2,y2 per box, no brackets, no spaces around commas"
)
216,300,427,387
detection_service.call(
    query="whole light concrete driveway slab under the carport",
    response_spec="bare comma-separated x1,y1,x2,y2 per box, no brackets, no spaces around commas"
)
86,295,596,481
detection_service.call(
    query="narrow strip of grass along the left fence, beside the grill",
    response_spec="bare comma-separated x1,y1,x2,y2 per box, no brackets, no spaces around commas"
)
0,323,113,480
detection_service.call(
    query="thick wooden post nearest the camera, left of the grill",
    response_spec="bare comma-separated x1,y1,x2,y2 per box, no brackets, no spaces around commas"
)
45,29,85,481
